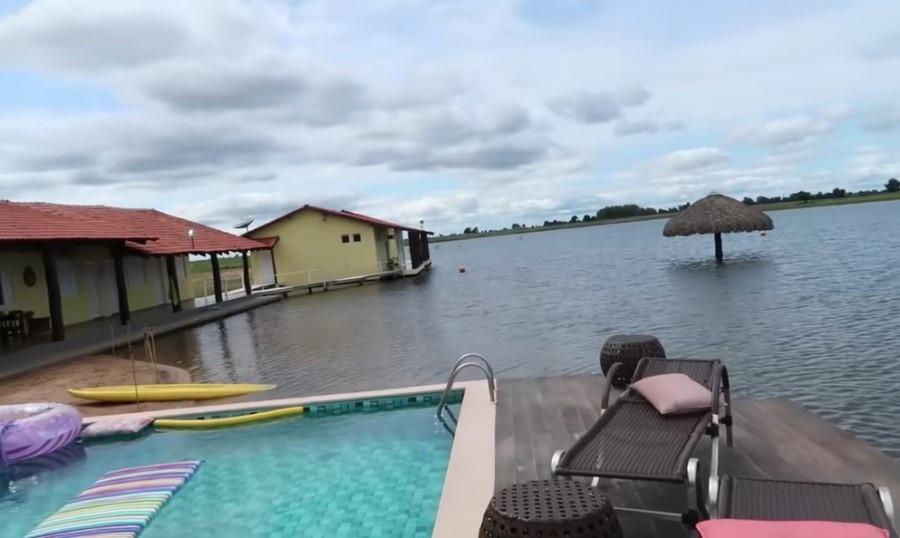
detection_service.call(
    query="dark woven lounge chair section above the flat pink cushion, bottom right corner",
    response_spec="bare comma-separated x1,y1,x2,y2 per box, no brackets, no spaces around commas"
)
711,474,897,538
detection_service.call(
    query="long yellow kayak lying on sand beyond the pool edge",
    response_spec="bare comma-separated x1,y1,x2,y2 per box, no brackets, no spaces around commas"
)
69,383,275,402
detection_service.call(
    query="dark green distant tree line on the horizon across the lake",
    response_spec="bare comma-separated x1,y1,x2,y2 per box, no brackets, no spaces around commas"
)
463,178,900,235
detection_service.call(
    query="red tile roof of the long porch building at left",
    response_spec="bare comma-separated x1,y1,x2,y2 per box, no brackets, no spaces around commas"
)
0,201,268,255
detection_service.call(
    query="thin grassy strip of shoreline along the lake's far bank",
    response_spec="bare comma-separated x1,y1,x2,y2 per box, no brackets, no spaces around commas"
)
428,192,900,243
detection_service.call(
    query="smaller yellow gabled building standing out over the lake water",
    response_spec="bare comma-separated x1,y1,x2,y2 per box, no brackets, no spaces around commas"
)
244,205,431,287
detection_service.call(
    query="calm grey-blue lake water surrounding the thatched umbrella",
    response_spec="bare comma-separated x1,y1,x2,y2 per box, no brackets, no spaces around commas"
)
148,202,900,457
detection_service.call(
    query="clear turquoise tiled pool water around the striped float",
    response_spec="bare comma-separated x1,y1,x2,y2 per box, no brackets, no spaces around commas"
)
0,407,452,538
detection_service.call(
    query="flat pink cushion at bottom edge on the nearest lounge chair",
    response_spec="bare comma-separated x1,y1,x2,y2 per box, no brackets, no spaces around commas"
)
697,519,889,538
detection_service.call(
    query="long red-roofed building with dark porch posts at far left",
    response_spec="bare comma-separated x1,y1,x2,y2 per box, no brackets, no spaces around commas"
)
0,201,269,340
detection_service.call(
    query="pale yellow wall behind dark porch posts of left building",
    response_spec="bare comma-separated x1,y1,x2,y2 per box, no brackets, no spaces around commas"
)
0,247,190,325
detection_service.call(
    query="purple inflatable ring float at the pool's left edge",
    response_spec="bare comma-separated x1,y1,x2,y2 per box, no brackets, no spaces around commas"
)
0,403,81,466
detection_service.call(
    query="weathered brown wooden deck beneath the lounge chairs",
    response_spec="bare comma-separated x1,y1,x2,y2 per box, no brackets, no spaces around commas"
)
495,375,900,538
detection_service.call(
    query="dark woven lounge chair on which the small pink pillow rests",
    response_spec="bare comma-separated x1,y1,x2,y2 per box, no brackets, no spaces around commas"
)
550,358,732,524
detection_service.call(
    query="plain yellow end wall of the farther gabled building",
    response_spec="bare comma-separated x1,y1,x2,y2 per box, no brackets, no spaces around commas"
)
250,209,394,285
